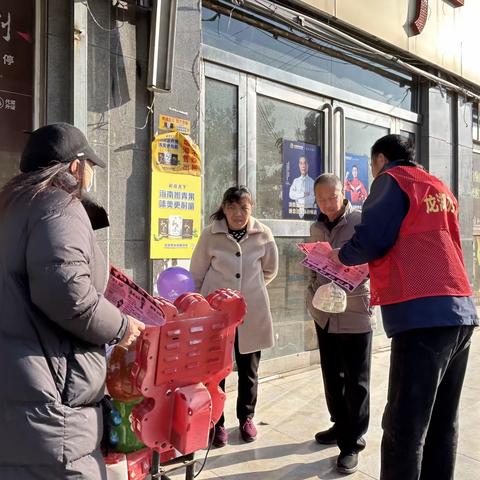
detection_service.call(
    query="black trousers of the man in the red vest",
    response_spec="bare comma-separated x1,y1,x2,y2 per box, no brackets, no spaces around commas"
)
380,326,473,480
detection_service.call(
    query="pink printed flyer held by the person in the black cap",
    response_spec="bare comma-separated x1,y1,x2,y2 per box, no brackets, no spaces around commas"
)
105,266,165,326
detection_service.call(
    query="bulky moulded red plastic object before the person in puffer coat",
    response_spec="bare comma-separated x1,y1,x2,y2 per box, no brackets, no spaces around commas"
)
132,289,246,455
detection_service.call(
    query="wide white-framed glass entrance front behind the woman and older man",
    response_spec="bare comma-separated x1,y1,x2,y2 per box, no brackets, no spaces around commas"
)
202,62,418,358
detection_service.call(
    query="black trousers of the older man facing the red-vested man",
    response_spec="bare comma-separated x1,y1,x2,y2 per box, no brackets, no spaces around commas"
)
315,323,372,454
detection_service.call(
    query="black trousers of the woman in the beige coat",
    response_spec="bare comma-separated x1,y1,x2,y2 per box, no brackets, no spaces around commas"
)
217,334,261,426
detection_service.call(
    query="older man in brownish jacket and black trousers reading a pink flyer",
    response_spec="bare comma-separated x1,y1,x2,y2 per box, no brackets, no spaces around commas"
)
307,173,372,473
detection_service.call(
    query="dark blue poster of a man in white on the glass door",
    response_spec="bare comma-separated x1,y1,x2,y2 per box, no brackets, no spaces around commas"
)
282,140,322,220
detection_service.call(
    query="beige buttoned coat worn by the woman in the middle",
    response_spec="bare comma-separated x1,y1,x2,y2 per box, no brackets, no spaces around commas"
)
190,217,278,353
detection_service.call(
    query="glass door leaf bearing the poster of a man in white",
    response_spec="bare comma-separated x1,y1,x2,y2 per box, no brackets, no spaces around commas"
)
255,79,332,232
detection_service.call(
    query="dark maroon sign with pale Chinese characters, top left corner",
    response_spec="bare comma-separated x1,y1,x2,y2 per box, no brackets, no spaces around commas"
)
0,0,35,153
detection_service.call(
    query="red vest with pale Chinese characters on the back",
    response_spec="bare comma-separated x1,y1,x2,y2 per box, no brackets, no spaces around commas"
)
368,167,472,305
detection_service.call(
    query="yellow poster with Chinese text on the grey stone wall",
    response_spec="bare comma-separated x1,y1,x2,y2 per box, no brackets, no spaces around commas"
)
150,172,202,259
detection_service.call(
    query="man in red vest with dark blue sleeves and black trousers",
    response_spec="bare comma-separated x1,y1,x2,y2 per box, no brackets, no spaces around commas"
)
332,135,478,480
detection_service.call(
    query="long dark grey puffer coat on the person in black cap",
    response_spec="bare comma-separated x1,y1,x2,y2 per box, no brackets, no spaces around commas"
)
0,190,123,480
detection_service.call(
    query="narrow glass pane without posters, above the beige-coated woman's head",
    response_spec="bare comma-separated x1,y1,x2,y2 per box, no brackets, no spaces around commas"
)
203,78,238,225
